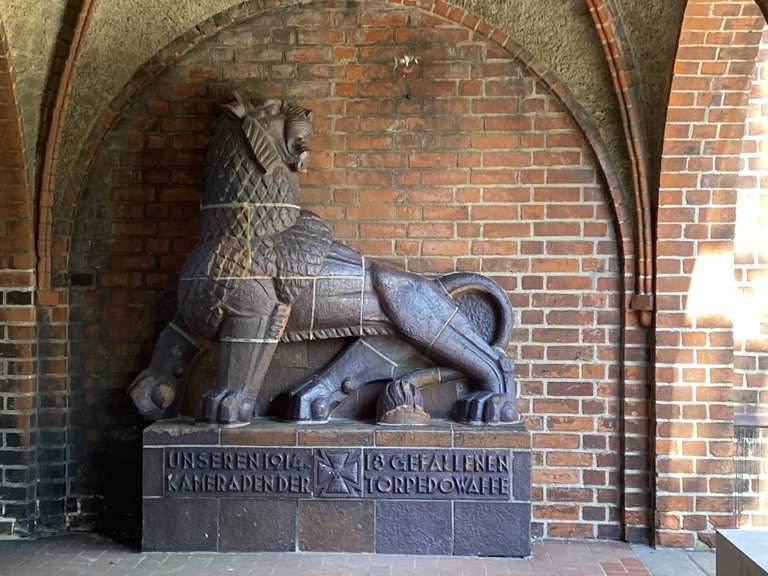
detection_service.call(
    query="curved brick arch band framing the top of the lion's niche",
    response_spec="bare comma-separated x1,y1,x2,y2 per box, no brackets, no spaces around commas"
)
43,0,642,291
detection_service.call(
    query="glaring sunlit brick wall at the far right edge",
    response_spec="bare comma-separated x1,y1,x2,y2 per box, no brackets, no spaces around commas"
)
733,26,768,527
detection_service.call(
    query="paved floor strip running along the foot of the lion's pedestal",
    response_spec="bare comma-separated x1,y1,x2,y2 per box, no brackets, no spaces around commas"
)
0,534,714,576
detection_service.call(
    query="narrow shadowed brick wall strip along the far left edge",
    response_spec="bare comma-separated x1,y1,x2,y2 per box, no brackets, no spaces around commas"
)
0,22,36,535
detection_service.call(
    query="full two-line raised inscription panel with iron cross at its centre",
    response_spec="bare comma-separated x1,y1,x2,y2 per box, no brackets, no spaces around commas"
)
164,446,513,500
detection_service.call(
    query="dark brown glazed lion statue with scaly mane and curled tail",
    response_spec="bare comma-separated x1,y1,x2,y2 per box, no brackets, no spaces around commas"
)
129,97,518,424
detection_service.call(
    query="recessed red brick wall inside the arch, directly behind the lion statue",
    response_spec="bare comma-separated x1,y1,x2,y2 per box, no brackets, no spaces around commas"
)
57,4,624,538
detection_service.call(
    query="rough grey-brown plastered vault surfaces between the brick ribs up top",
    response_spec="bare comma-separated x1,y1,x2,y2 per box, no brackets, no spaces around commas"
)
0,0,685,244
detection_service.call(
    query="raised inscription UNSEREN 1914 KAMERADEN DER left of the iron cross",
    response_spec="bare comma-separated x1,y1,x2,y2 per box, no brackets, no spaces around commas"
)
165,447,313,498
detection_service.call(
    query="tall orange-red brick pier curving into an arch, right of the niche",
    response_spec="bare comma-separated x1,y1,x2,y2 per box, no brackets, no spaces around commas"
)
654,0,766,547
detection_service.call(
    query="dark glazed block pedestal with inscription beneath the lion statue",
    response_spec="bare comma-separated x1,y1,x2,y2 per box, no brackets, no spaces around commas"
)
143,420,531,557
